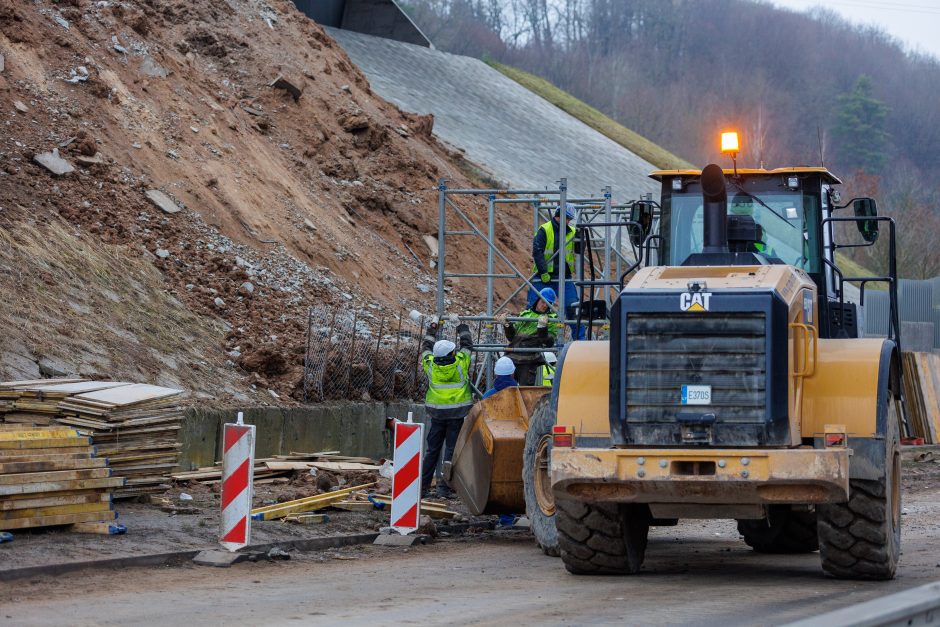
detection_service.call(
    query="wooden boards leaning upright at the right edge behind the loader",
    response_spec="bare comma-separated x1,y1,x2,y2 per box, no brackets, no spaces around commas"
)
901,352,940,444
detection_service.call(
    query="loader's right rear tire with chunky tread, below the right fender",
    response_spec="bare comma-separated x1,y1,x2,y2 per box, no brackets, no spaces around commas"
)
816,393,901,580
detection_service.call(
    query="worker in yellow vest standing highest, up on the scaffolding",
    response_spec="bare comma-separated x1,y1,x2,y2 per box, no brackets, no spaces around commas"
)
527,203,586,340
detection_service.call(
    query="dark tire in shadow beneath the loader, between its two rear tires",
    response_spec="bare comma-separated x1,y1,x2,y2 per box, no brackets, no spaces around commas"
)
738,505,819,554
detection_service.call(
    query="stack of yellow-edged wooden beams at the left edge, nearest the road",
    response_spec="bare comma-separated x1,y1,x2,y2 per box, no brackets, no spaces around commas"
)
0,425,124,530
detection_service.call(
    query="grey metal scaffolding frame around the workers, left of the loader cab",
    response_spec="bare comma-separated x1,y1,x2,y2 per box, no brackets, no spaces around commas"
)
436,178,648,387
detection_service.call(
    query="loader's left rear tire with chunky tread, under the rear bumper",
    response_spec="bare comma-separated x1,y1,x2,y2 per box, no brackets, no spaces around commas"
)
556,499,651,575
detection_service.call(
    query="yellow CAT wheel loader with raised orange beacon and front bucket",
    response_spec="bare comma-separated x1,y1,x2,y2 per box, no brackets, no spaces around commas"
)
452,141,904,579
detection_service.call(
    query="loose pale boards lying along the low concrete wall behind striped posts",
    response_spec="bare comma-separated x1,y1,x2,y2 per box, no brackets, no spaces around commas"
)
172,451,382,485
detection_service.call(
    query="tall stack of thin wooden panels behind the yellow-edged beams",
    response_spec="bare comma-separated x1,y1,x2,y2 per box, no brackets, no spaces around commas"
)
0,379,183,498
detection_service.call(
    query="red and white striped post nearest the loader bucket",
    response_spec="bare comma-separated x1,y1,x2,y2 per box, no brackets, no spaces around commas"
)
391,412,424,536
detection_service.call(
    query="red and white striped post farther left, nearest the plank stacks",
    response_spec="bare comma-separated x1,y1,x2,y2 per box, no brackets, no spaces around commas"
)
219,412,255,551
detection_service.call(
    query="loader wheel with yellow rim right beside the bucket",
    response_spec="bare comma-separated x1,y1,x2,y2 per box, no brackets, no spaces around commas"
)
522,394,558,557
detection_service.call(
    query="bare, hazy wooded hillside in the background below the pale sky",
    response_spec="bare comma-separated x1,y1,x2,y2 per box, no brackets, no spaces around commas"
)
403,0,940,278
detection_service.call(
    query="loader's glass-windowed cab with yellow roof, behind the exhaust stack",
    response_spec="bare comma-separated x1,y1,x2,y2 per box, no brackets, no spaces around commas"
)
651,167,860,337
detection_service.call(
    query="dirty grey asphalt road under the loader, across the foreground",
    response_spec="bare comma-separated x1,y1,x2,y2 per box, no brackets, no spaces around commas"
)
0,489,940,627
